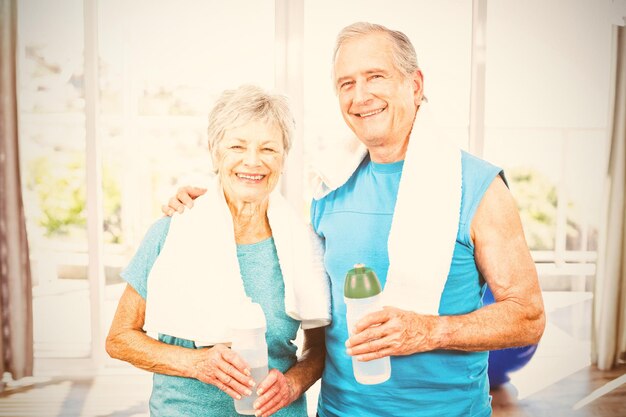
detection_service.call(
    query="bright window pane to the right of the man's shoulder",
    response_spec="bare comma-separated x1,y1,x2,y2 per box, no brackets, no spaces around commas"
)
484,1,611,291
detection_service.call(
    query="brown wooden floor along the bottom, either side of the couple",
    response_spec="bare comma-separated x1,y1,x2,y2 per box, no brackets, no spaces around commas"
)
0,365,626,417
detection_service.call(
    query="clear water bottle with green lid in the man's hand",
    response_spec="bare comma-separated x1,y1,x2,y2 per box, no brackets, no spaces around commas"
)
344,264,391,385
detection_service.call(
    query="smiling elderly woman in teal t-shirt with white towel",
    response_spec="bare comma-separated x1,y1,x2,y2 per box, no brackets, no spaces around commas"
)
106,86,330,417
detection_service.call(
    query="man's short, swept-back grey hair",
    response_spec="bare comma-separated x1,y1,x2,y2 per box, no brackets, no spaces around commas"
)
333,22,419,83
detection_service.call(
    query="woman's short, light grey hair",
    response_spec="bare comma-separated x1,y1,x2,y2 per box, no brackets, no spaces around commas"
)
208,84,295,162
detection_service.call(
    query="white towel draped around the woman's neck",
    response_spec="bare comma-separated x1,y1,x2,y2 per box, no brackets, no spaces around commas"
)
144,178,330,346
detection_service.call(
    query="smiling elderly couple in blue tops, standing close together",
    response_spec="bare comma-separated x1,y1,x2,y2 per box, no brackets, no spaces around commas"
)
107,22,545,417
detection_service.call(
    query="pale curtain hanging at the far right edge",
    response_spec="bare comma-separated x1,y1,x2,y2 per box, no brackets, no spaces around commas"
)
592,27,626,370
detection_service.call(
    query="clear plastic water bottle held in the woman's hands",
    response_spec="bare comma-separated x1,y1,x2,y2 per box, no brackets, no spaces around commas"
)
231,299,268,415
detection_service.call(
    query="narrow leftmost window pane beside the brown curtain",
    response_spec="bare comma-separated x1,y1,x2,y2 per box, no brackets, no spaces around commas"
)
18,0,91,357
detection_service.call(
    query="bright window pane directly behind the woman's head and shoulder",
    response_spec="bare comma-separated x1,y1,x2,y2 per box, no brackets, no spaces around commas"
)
98,5,274,360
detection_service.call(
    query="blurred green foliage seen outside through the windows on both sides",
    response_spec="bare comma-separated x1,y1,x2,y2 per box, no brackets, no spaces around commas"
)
27,158,580,250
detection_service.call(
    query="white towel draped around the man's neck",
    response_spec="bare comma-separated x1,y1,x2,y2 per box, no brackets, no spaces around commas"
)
313,106,461,315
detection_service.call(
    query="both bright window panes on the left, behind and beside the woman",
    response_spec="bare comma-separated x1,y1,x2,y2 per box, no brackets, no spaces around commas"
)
18,0,275,368
